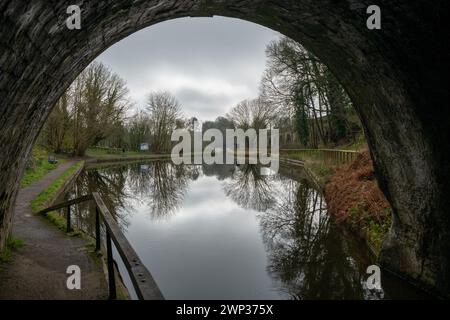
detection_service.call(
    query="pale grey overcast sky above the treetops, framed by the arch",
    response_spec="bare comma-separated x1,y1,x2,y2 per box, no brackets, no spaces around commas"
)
97,17,280,121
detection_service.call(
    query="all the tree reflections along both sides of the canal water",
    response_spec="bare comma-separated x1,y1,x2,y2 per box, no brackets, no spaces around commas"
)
62,161,380,299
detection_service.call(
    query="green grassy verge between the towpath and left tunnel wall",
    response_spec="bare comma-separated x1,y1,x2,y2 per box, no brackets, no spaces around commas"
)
20,147,65,188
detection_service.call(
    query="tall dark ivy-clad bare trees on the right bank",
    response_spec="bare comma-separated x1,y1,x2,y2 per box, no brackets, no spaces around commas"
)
260,37,359,147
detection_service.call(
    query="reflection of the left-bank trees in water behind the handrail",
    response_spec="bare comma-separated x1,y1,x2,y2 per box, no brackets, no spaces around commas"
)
67,161,200,230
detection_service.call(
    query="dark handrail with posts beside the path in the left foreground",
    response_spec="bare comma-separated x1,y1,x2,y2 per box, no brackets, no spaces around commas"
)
39,192,164,300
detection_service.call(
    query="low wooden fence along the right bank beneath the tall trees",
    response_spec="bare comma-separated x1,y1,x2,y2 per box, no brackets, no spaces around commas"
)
280,149,359,164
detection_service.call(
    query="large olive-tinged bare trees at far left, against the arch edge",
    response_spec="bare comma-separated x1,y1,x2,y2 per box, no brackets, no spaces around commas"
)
40,63,130,156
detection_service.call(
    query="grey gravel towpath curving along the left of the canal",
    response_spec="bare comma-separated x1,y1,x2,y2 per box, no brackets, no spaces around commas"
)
0,161,108,300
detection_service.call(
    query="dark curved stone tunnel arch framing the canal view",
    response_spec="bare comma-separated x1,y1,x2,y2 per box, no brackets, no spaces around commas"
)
0,0,450,295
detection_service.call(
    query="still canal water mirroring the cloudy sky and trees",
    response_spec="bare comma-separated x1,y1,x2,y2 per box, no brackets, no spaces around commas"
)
61,161,428,299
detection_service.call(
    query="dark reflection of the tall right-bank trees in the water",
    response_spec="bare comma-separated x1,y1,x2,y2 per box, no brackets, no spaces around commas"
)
258,179,370,299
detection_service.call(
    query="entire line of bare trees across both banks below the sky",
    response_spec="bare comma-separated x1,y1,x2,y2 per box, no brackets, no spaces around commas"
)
39,37,362,156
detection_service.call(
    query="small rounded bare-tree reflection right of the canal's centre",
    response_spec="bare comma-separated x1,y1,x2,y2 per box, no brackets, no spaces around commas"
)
224,164,275,211
